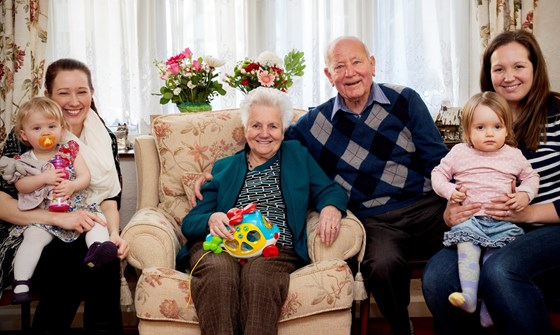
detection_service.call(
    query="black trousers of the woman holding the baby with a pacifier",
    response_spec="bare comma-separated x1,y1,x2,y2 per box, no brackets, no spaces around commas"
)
32,235,122,335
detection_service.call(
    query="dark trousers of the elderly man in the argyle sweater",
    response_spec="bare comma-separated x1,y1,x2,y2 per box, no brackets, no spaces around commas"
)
361,193,447,335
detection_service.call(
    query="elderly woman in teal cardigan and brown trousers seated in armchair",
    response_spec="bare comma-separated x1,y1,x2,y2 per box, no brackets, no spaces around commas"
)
177,87,347,334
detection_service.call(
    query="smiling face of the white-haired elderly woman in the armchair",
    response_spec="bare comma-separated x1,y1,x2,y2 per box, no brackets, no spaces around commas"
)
245,105,284,163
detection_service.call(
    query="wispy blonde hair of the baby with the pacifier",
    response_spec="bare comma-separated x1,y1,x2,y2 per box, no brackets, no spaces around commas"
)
14,97,71,145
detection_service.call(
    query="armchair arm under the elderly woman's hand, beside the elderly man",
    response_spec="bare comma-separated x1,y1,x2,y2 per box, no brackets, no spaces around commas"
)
307,211,365,263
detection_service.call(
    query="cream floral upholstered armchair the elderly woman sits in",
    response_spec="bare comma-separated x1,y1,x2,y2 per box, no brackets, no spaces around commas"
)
122,109,365,335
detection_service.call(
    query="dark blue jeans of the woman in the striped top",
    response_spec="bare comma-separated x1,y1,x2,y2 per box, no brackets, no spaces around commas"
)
422,225,560,335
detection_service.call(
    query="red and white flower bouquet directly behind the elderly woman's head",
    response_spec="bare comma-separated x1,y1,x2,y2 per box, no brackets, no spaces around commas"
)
224,50,305,94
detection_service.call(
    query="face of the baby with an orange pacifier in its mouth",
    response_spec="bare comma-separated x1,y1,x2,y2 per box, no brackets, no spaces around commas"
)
19,111,64,154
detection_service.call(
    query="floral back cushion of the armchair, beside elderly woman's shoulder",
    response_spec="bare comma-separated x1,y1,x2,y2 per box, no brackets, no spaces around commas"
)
152,110,253,225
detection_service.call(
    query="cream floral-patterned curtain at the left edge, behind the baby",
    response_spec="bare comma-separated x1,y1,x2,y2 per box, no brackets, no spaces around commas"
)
0,0,48,152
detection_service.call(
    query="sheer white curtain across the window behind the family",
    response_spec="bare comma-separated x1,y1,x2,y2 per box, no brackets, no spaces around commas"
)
47,0,470,133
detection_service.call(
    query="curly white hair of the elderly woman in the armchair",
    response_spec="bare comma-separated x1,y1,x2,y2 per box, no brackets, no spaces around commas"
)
239,86,294,130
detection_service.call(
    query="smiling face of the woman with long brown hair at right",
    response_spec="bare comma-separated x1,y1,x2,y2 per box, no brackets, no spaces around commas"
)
490,42,533,113
